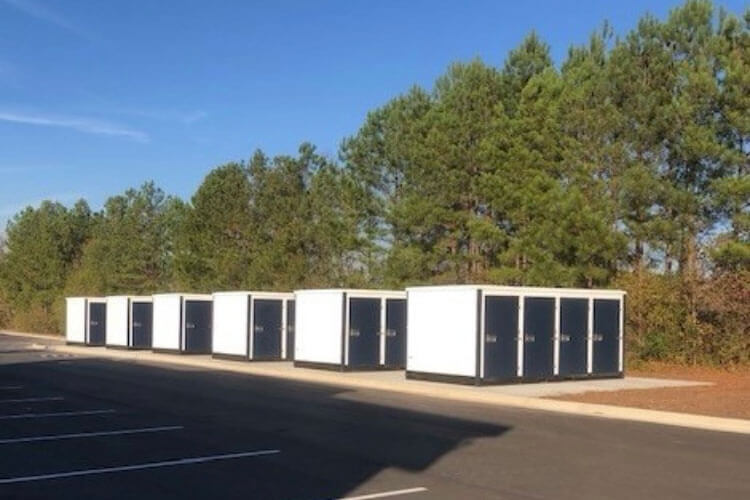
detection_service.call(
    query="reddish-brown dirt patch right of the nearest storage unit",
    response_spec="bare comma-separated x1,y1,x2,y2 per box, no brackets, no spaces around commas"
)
551,363,750,419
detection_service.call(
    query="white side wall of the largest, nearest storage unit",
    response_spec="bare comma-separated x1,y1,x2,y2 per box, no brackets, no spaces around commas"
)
406,287,477,377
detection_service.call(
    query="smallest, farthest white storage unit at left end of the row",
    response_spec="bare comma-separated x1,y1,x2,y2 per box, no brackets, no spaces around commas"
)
65,297,107,346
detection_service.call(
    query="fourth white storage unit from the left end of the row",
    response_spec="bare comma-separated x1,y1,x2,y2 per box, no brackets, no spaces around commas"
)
212,292,294,360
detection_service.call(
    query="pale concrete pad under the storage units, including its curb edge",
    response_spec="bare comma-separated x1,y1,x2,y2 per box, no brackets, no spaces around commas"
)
2,332,750,434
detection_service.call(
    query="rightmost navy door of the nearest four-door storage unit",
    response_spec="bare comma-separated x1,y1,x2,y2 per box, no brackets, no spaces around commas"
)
592,299,620,374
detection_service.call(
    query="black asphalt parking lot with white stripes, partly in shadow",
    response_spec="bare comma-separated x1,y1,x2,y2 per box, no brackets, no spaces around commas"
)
0,336,750,500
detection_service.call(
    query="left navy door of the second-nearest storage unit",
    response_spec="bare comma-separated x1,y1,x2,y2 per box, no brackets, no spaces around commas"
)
348,298,380,368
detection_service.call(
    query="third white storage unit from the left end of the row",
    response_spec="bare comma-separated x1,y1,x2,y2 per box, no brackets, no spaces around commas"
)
152,293,213,354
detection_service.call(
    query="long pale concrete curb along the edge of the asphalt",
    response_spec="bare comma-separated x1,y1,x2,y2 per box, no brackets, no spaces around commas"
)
2,332,750,434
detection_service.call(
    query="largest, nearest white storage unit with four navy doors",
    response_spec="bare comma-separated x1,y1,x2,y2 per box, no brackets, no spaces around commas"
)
406,285,625,384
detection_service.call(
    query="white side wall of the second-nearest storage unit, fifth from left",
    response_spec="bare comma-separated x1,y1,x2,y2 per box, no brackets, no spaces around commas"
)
294,290,344,364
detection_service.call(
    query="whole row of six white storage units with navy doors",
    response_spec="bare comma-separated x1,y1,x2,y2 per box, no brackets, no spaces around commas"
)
67,285,625,384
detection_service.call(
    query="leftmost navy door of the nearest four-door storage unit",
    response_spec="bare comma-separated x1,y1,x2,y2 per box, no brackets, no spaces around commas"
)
484,296,518,380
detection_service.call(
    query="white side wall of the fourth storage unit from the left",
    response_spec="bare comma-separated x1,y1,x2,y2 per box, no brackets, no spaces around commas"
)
212,293,250,356
